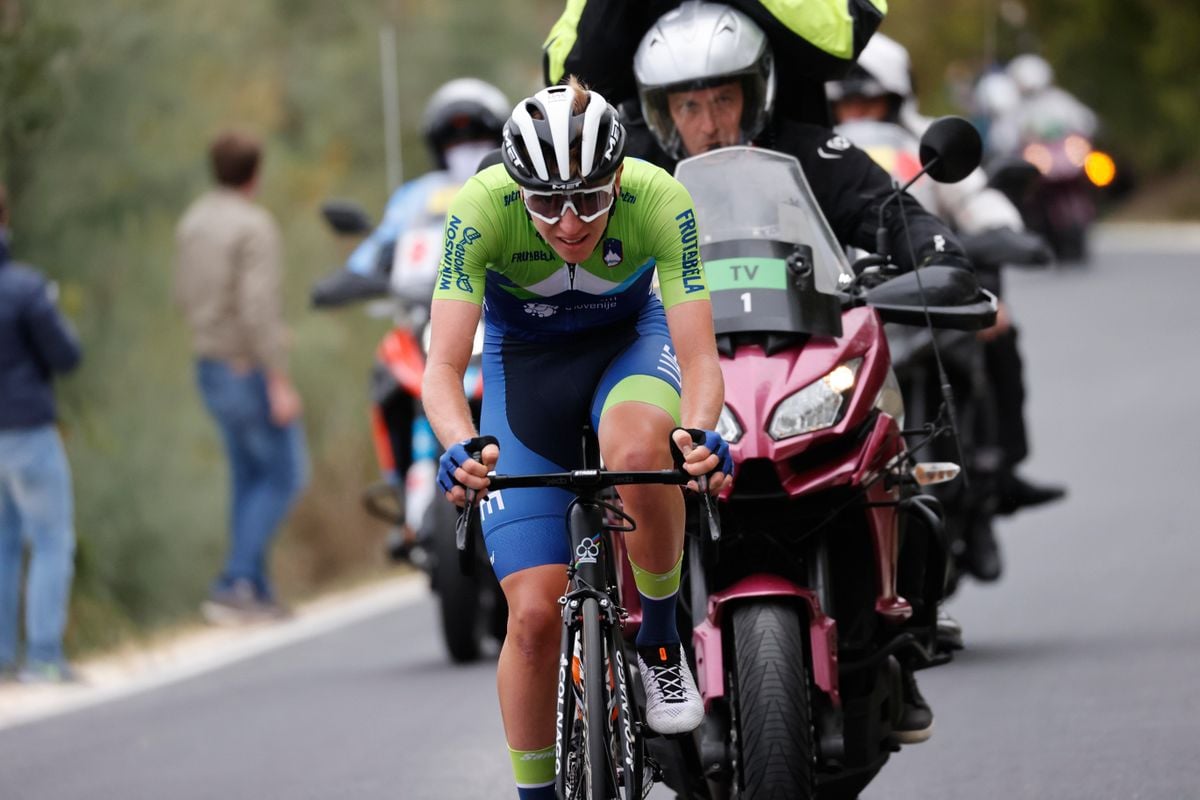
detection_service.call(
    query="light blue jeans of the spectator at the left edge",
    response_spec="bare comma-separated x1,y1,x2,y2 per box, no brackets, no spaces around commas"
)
0,425,74,667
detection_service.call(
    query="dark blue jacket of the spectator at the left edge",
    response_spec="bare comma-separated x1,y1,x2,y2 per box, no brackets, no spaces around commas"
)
0,231,80,431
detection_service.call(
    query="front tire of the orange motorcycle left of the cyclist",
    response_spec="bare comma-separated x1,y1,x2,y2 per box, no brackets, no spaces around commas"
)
430,500,488,663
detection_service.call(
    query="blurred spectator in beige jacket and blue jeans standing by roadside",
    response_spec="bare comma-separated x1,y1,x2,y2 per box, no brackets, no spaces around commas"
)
175,132,307,624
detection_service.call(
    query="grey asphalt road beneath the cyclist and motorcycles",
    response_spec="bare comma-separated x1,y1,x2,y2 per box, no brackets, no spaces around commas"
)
0,226,1200,800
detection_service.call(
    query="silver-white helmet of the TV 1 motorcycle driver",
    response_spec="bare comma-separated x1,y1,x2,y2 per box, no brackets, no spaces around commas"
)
634,1,775,157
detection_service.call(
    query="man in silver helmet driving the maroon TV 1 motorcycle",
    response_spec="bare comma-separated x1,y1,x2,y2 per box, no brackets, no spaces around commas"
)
634,1,971,744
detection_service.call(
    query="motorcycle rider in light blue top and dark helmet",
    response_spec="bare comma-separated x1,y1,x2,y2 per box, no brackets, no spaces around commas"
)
346,78,510,558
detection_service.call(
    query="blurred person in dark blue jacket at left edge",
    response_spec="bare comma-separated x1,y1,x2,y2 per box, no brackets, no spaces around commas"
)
0,186,79,682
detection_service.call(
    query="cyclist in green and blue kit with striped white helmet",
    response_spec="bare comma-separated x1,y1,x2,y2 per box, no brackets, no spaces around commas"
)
424,80,732,798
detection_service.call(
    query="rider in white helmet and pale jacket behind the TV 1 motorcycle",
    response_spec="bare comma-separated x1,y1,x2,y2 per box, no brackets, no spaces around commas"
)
826,34,1066,581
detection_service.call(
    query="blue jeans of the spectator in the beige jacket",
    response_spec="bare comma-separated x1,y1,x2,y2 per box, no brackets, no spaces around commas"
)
196,359,308,600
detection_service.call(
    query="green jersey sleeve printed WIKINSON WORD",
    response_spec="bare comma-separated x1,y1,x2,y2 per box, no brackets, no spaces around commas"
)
433,176,499,305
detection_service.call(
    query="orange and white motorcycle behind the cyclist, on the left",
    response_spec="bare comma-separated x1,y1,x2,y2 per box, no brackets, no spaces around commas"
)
312,201,508,663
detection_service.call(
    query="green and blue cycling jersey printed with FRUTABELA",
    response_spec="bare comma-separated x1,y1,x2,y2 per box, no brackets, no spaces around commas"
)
433,158,708,341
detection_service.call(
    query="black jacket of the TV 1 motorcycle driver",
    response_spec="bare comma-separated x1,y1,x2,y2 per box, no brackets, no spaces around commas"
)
625,119,971,270
